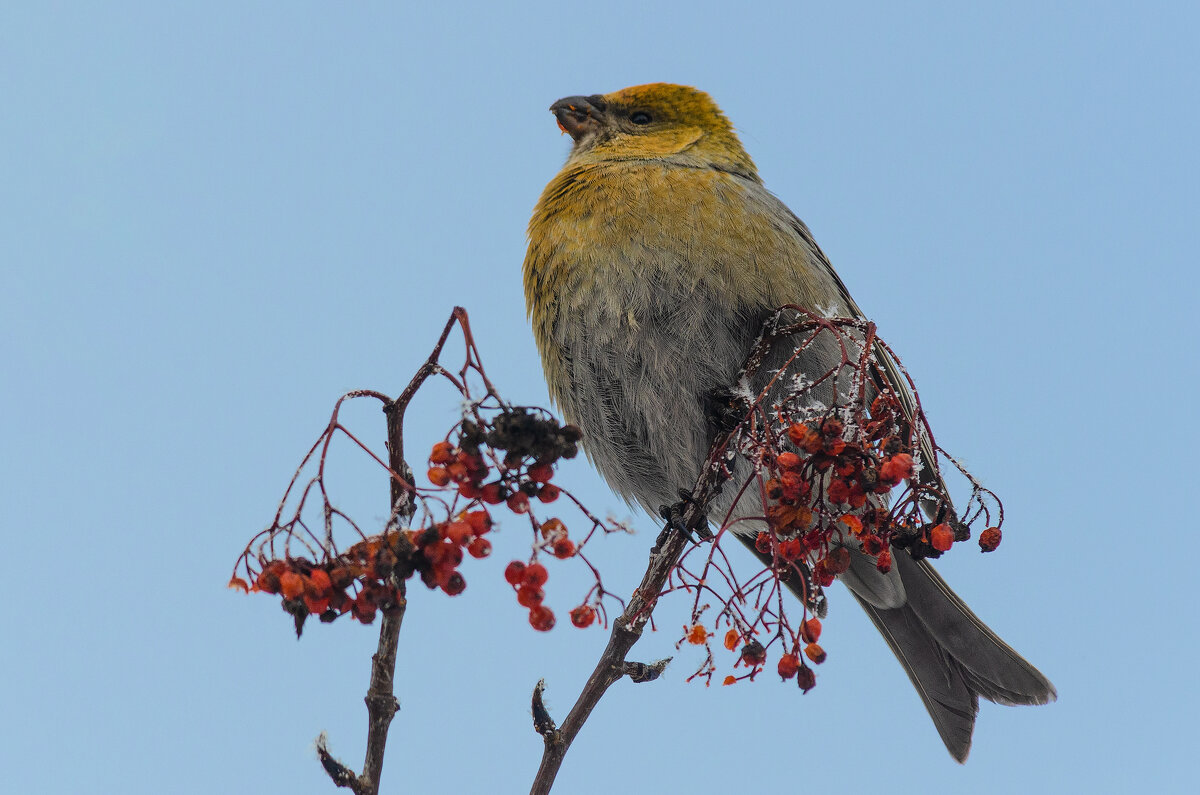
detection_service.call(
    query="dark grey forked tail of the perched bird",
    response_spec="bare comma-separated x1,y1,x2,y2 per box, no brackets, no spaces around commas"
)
847,550,1056,761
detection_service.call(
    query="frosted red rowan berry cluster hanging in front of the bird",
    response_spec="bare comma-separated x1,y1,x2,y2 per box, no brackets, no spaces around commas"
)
677,322,1002,691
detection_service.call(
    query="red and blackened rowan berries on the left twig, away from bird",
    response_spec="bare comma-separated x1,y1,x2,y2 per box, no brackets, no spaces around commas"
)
230,408,604,633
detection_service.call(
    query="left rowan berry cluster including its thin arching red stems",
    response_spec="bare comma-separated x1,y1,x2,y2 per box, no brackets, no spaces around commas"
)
229,314,620,635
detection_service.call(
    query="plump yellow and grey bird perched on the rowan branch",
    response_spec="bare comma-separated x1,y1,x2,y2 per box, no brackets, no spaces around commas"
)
522,83,1057,763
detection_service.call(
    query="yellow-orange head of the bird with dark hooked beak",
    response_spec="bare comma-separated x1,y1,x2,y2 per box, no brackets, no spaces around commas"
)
550,83,756,177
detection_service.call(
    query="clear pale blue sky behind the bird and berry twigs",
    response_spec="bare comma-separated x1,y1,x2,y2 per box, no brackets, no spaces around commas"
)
0,2,1200,794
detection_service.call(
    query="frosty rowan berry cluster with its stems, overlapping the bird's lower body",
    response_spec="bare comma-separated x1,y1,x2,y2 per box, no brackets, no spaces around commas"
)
667,306,1003,692
